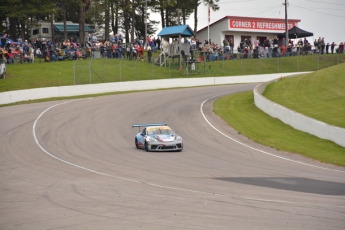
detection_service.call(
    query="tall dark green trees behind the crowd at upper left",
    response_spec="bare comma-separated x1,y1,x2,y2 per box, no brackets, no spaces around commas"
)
0,0,219,41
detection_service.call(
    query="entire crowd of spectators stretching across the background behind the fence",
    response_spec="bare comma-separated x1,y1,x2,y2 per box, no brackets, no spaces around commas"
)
0,34,344,64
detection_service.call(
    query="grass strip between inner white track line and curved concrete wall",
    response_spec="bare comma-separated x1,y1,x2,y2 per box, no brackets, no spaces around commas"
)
214,88,345,167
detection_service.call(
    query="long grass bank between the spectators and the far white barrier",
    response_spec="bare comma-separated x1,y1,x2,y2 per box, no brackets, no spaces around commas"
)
0,53,345,92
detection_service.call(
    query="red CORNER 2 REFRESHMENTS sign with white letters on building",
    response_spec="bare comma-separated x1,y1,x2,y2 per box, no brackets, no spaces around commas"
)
229,19,296,30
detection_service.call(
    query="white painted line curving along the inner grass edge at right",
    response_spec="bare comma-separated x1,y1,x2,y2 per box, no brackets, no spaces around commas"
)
200,94,345,173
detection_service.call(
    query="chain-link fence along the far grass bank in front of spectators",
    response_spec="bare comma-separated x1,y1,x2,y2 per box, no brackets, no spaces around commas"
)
73,50,345,84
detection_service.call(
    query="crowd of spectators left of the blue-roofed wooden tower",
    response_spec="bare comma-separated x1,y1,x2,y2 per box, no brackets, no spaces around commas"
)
0,34,160,64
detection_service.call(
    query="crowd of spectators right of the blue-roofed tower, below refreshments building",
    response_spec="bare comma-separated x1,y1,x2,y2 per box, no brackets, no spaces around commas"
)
187,36,344,61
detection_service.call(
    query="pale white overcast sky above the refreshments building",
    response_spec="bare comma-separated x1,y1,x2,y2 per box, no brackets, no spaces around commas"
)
151,0,345,44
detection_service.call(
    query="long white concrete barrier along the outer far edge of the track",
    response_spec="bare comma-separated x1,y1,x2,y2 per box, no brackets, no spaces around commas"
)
0,73,296,104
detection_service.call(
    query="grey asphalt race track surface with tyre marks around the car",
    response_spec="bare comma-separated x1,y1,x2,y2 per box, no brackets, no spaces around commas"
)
0,84,345,230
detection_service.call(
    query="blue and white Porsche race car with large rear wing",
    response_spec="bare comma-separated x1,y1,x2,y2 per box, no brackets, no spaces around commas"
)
132,123,183,151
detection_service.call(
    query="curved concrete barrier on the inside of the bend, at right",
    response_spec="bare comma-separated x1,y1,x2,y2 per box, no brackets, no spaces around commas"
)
254,75,345,147
